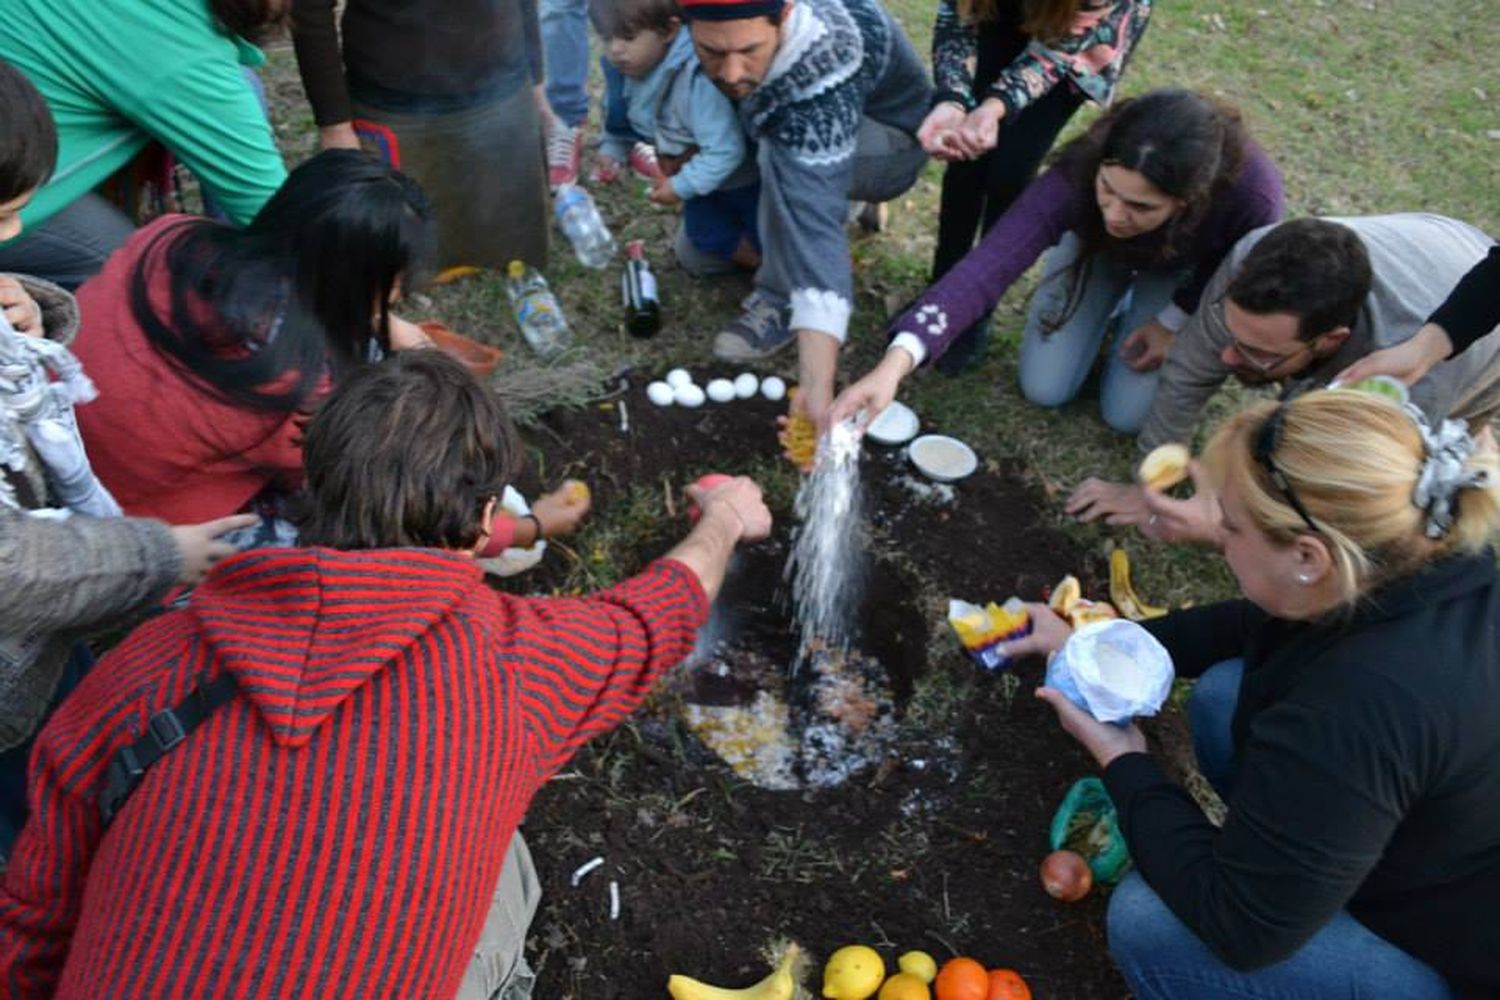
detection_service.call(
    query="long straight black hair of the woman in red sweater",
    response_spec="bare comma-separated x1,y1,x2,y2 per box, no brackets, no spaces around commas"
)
131,150,434,412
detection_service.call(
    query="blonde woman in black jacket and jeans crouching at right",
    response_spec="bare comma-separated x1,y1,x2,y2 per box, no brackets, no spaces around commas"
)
1017,391,1500,1000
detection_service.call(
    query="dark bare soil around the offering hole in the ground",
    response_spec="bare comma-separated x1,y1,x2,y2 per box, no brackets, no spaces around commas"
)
510,381,1124,1000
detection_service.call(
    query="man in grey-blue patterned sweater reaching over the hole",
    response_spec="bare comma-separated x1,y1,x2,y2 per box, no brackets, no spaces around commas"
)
680,0,932,421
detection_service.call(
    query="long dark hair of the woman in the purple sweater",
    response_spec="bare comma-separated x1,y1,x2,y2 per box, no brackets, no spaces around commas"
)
1047,88,1250,330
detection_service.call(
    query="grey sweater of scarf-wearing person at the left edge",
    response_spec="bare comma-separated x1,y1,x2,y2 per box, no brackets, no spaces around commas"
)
0,274,182,751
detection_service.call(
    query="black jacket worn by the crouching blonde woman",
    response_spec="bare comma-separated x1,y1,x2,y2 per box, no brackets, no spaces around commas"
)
1104,552,1500,988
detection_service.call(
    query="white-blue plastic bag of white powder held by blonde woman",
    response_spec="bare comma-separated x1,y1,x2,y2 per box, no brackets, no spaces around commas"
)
1047,619,1175,724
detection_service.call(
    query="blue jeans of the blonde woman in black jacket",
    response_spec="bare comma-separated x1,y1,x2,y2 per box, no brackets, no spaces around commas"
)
1109,660,1454,1000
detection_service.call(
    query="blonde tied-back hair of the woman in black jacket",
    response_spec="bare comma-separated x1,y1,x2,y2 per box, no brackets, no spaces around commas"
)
1205,390,1500,606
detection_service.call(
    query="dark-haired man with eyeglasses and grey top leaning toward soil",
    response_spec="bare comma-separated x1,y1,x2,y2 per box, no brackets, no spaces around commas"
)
1067,213,1500,543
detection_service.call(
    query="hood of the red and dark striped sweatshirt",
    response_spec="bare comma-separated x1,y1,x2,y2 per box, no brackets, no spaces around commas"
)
189,549,482,747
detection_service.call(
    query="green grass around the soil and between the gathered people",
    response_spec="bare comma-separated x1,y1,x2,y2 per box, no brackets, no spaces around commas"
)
270,0,1500,601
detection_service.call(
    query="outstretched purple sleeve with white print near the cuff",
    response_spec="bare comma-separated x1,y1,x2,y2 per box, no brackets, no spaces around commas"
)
890,165,1089,360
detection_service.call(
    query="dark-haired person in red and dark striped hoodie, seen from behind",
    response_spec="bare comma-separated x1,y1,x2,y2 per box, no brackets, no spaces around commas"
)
0,351,771,997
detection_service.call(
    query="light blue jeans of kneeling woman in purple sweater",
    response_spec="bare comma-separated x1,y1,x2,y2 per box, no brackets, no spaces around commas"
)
1020,232,1181,435
